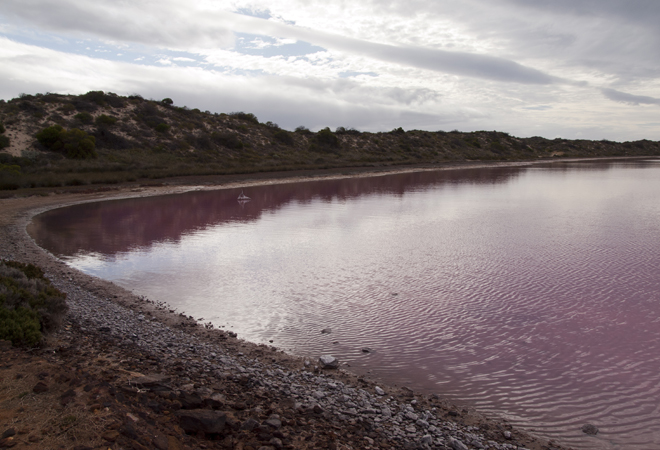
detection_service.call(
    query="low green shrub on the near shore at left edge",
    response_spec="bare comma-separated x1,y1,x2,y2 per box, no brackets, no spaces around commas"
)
0,261,67,346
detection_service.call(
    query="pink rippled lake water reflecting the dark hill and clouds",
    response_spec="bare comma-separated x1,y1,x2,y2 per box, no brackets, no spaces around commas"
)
31,160,660,449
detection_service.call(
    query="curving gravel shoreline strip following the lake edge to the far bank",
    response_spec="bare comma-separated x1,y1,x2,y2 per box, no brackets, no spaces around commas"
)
0,158,620,450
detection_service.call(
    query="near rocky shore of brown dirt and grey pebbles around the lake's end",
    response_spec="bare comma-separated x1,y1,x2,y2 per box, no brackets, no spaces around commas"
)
0,169,561,450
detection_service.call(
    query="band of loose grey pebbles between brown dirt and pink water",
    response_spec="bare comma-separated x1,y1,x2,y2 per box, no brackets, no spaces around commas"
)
37,268,540,450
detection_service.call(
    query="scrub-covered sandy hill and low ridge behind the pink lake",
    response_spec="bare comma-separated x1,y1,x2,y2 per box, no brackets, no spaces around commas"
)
0,91,660,189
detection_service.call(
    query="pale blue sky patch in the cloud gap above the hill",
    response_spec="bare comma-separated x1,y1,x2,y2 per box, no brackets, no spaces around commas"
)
234,33,326,58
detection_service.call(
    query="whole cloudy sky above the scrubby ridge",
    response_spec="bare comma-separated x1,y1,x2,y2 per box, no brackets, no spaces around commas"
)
0,0,660,141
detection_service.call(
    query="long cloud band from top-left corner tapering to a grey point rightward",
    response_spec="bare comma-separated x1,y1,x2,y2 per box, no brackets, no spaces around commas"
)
3,0,562,85
